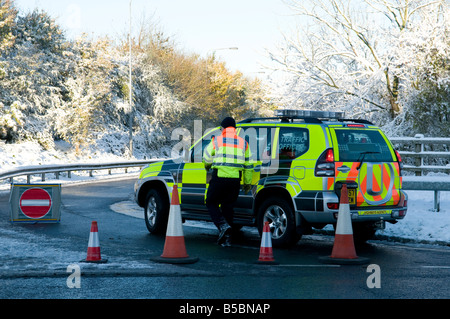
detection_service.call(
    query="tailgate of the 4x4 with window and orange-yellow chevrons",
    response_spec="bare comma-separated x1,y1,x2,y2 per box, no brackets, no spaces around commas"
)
330,125,401,207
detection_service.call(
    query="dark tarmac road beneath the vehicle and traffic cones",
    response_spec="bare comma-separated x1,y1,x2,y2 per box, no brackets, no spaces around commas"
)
0,179,450,302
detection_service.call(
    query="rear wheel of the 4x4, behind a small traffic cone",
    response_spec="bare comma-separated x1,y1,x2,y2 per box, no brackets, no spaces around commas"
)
258,198,301,247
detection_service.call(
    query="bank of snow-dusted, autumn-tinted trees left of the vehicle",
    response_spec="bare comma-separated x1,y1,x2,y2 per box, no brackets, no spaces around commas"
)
0,4,270,158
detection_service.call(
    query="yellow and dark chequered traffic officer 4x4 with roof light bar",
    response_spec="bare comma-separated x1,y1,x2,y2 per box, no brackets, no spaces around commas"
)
135,110,407,246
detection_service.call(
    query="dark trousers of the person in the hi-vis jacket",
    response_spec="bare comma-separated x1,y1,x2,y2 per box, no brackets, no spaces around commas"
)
206,170,241,228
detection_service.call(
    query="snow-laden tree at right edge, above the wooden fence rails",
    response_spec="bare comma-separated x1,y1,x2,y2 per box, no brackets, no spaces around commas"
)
393,2,450,136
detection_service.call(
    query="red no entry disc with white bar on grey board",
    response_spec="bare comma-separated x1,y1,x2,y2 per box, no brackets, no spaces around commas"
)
19,188,52,219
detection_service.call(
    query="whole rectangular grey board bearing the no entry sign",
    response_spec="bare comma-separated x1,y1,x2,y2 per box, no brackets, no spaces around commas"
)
10,184,61,223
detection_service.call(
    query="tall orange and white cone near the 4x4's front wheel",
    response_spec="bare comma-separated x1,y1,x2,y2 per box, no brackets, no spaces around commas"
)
152,185,198,264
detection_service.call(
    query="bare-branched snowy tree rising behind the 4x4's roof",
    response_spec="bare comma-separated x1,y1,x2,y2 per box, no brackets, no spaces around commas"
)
270,0,449,131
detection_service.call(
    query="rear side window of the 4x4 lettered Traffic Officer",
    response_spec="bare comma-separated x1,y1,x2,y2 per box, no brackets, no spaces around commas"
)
278,127,309,160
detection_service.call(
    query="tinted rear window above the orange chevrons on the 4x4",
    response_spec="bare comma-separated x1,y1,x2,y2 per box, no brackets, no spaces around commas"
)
335,129,393,162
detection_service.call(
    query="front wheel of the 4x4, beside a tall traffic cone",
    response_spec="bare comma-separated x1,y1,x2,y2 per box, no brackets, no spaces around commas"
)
144,189,170,235
